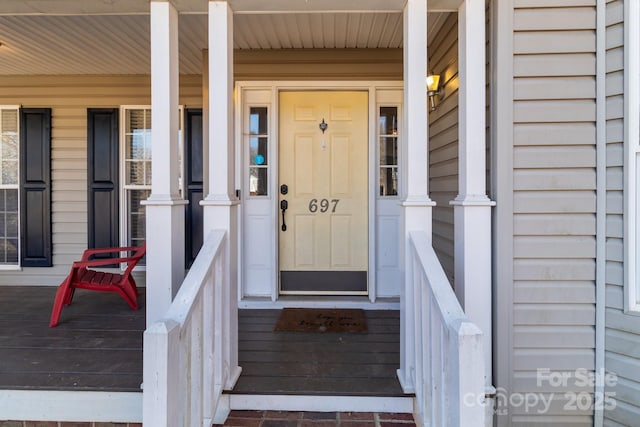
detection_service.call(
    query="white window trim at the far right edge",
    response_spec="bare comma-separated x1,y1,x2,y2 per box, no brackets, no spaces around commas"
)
624,1,640,315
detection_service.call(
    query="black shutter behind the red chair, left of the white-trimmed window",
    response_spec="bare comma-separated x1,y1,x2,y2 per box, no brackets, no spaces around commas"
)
87,108,119,255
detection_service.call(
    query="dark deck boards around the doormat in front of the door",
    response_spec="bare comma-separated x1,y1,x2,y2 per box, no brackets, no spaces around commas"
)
232,310,404,396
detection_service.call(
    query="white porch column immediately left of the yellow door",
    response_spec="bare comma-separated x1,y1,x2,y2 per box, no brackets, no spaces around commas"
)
200,0,240,411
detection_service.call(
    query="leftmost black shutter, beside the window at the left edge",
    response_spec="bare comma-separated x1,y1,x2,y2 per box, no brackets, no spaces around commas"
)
20,108,52,267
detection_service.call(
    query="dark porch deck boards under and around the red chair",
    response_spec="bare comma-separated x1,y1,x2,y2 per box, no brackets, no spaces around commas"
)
0,286,145,391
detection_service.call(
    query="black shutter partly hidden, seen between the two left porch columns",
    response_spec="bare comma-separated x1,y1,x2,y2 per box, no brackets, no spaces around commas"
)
184,109,204,268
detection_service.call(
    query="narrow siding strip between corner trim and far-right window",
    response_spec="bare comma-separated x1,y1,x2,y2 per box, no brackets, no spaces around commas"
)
604,0,640,426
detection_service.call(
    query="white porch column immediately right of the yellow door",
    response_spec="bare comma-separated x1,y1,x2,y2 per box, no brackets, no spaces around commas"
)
398,0,435,392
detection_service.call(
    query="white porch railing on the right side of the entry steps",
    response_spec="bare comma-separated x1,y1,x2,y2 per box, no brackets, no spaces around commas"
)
407,232,485,427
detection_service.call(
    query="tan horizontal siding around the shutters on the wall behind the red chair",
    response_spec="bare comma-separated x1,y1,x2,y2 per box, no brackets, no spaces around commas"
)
0,75,202,285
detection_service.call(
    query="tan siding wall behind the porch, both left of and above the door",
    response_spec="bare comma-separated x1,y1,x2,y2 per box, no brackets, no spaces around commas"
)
0,49,402,286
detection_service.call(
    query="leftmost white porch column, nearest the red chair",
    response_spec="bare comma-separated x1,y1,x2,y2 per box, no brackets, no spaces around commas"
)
143,0,187,325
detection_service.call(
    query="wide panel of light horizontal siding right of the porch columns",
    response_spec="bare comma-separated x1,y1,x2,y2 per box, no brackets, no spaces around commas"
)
504,0,596,426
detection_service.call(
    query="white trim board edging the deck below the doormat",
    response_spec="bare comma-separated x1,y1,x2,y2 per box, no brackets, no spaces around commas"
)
227,394,414,414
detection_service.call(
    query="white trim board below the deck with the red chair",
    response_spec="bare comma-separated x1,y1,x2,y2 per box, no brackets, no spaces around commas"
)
0,390,142,423
